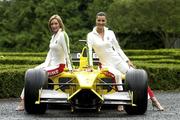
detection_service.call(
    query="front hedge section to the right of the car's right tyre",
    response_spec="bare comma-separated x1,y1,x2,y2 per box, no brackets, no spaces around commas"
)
137,64,180,90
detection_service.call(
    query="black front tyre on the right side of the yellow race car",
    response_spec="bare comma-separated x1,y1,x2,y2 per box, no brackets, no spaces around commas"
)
124,69,148,115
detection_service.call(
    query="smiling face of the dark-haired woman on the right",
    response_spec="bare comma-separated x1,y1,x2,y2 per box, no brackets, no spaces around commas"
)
96,16,106,30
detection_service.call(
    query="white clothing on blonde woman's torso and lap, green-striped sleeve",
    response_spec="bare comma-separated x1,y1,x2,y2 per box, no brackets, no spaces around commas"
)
36,29,72,70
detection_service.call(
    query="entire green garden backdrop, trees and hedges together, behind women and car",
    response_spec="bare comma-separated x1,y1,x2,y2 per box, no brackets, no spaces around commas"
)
0,0,180,98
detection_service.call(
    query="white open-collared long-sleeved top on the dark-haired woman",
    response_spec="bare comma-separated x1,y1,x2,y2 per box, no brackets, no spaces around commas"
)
87,27,129,66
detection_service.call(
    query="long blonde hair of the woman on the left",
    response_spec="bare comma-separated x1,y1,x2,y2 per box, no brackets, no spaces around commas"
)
48,15,65,31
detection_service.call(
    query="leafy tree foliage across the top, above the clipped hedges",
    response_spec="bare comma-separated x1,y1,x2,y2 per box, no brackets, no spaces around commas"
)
0,0,180,52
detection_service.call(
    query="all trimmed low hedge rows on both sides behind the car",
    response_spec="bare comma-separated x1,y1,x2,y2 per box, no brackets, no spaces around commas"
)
0,49,180,98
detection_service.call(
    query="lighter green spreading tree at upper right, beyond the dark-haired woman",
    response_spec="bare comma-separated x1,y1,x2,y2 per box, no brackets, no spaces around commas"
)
108,0,180,48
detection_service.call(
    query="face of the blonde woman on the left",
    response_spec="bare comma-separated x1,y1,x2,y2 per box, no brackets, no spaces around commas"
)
50,19,60,33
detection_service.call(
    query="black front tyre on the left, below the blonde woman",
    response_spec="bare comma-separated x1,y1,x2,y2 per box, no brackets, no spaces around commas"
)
24,69,48,114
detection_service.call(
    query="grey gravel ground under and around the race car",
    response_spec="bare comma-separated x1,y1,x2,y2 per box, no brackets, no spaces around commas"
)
0,91,180,120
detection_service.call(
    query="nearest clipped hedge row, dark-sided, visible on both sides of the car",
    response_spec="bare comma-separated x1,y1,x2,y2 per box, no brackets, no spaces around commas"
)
0,64,180,98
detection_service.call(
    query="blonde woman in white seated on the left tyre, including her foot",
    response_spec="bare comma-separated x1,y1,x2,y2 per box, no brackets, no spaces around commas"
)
16,15,72,111
